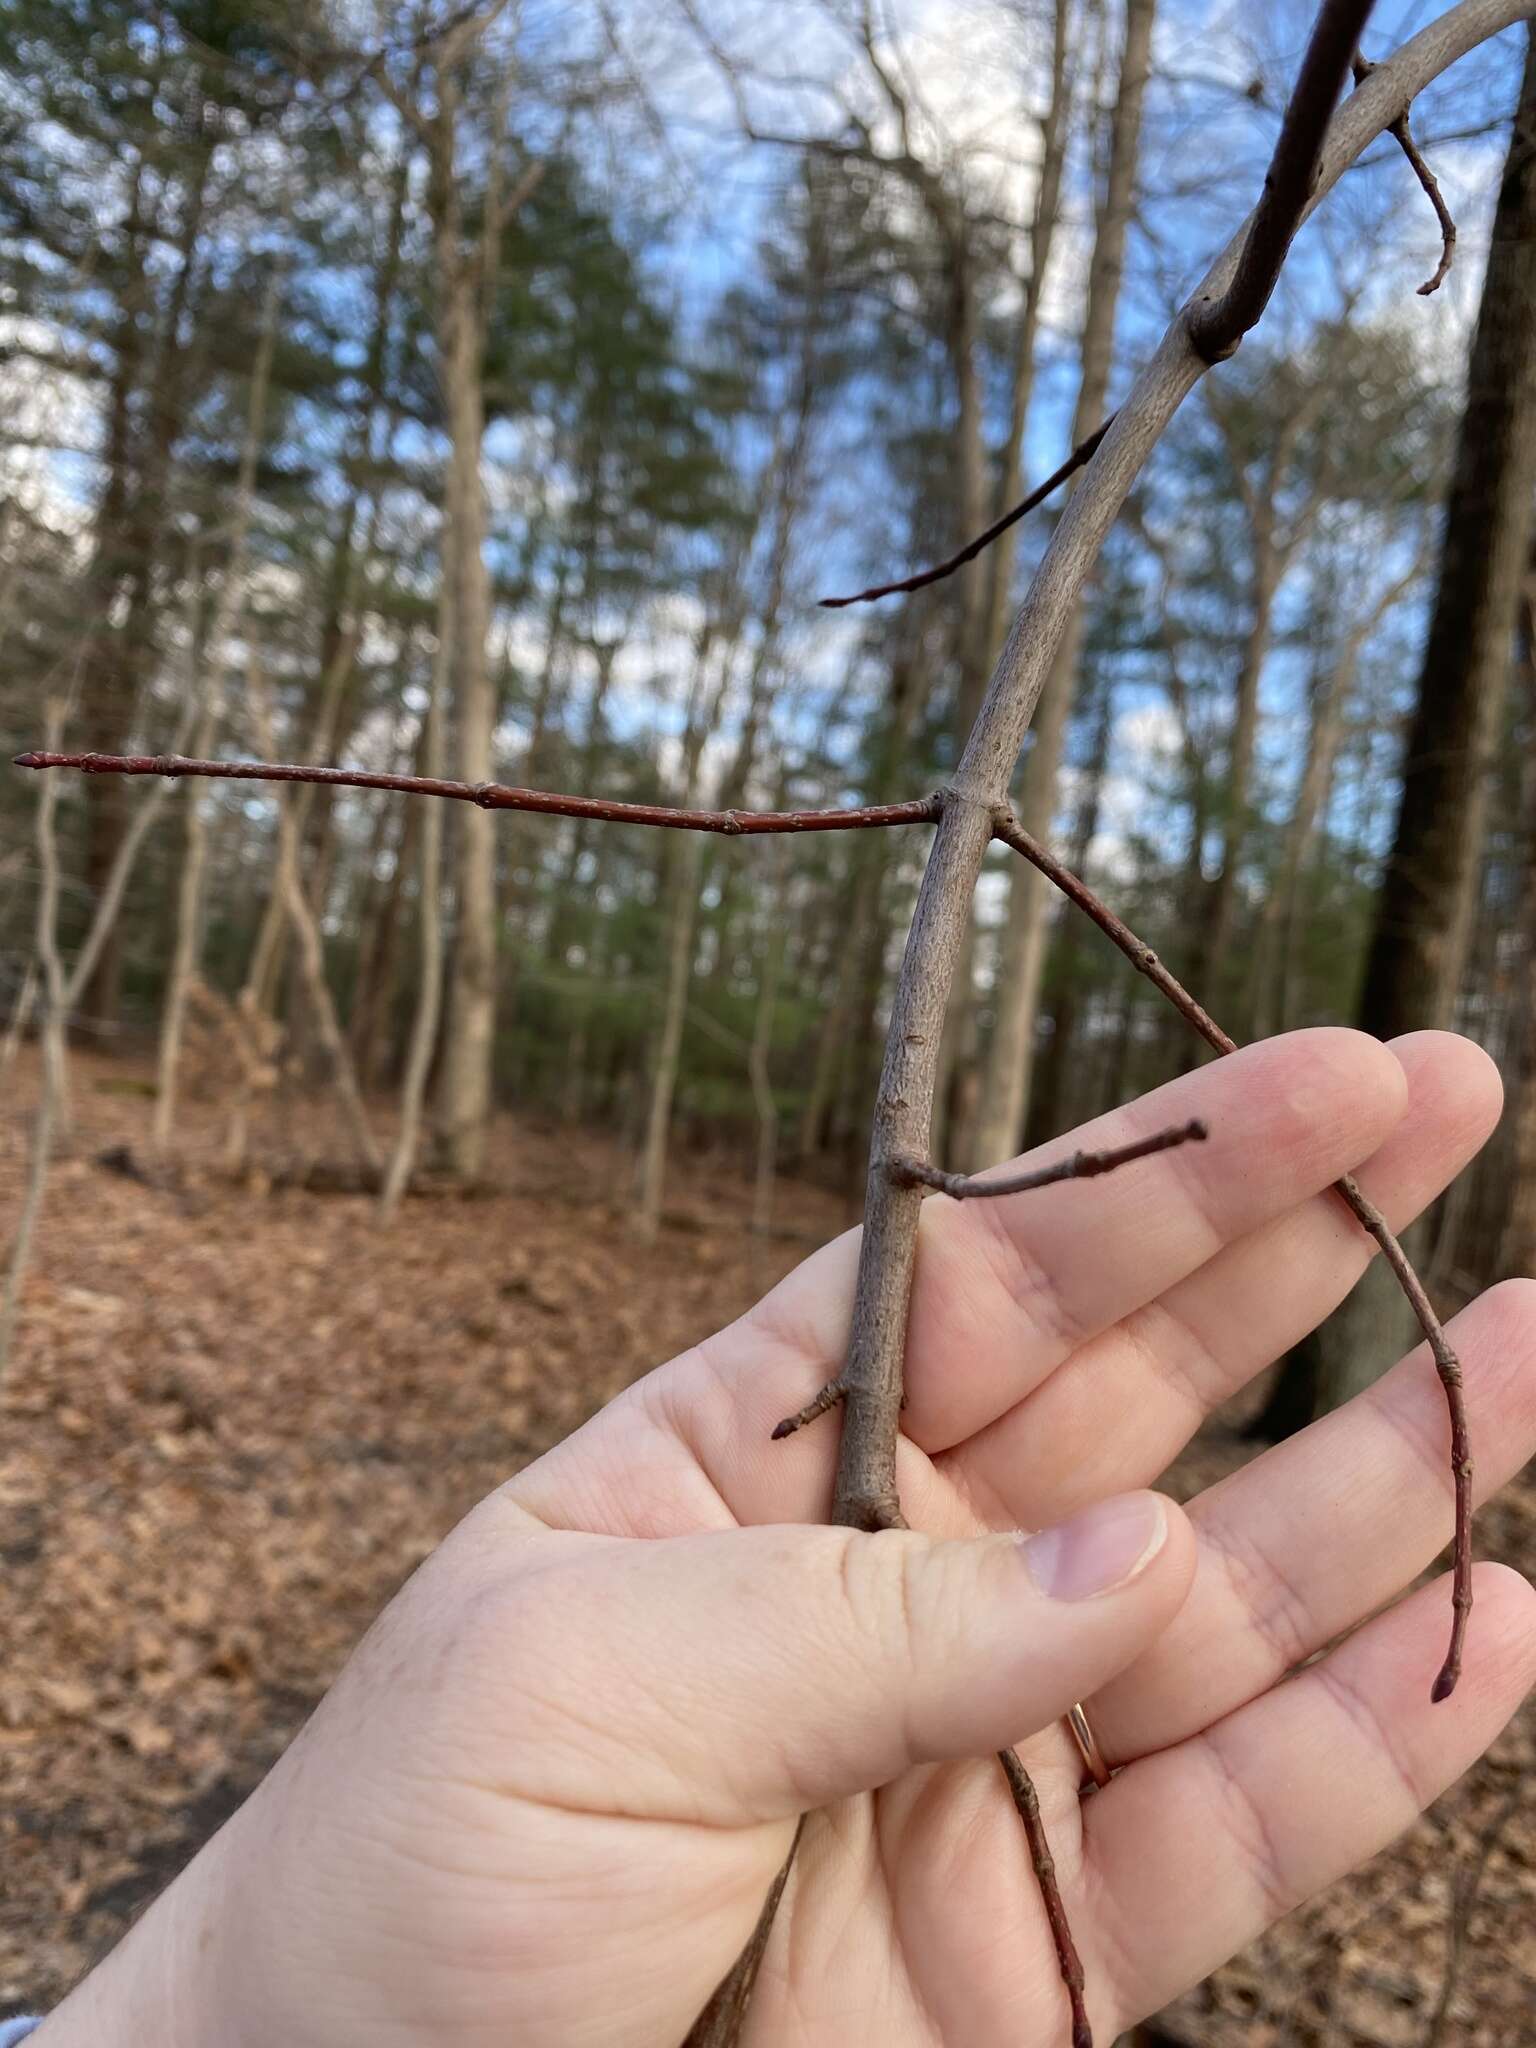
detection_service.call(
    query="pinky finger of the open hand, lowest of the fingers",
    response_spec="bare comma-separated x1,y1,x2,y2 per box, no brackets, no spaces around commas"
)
1083,1565,1536,2025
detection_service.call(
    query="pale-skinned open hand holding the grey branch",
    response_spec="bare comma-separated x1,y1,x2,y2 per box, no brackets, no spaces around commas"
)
37,1030,1536,2048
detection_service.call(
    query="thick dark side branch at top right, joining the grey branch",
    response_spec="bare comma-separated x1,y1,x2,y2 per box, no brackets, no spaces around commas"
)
1190,0,1372,362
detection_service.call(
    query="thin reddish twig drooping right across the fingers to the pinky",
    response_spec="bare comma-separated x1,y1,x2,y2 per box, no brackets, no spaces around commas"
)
995,811,1473,1702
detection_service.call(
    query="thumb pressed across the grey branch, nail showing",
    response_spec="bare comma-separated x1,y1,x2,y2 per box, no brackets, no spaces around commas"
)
505,1493,1194,1825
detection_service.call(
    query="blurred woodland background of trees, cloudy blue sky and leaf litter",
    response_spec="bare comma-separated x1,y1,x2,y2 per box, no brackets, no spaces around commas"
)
0,0,1536,2048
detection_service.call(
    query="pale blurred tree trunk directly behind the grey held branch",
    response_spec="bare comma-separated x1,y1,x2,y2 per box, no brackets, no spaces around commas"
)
963,0,1155,1169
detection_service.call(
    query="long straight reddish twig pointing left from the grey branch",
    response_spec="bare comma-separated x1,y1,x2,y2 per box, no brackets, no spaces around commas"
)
14,752,944,840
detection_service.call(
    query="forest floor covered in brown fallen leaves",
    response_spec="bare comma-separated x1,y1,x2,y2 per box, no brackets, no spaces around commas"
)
0,1055,1536,2048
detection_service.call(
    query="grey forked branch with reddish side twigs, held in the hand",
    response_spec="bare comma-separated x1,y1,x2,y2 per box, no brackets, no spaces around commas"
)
12,12,1522,2048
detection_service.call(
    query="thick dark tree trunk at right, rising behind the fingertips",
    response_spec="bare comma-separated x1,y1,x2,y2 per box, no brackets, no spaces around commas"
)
1319,29,1536,1407
